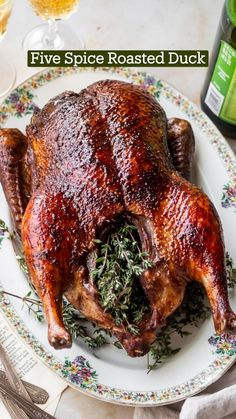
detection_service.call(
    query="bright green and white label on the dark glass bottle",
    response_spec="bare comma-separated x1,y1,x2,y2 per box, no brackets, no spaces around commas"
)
205,41,236,125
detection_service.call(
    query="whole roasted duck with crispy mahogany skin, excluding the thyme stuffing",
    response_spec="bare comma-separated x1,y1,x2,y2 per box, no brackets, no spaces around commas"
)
0,80,236,356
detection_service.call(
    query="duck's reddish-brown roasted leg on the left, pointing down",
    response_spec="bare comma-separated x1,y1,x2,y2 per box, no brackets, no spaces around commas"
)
22,192,76,349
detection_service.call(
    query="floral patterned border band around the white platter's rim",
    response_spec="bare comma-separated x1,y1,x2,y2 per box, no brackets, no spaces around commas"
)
0,67,236,406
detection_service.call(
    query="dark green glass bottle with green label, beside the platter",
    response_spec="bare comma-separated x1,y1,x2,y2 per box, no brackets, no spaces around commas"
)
201,0,236,138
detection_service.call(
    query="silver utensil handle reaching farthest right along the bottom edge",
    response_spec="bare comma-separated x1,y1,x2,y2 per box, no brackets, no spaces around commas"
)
0,380,55,419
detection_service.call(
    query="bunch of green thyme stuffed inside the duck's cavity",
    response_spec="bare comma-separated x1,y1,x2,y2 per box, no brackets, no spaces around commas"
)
92,224,152,334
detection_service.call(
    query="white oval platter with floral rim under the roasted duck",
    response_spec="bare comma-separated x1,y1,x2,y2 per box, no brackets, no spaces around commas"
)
0,68,236,406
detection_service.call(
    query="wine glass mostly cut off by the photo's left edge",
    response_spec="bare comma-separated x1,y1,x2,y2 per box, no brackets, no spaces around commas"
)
0,0,15,97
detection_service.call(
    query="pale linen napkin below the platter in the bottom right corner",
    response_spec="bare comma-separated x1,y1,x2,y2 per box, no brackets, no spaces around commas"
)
133,364,236,419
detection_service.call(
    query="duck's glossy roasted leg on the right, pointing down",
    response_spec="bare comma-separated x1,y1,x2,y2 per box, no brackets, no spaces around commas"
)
153,172,236,334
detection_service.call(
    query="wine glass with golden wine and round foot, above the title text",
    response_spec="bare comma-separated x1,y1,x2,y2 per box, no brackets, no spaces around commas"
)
23,0,84,52
